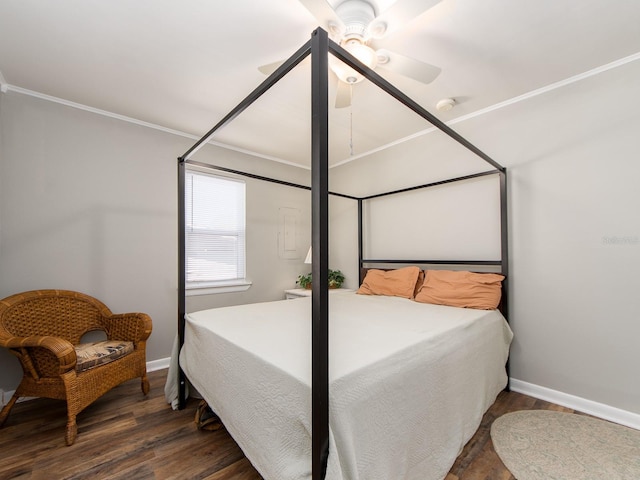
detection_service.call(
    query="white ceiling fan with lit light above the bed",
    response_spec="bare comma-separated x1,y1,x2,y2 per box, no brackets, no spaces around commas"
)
259,0,441,108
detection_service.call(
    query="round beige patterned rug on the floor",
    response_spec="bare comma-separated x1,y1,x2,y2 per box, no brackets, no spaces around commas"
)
491,410,640,480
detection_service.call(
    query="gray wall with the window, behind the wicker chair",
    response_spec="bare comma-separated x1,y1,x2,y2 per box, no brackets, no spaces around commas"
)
0,91,310,391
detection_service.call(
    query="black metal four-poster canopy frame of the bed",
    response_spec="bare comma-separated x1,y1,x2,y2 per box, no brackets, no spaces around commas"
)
178,28,509,480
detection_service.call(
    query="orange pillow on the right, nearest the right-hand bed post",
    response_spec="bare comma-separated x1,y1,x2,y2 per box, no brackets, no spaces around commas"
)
415,270,504,310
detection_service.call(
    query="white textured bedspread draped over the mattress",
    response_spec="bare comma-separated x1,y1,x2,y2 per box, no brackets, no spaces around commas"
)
172,293,512,480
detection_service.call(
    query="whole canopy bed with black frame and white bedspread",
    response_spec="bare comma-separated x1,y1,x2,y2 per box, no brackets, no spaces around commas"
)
177,29,511,480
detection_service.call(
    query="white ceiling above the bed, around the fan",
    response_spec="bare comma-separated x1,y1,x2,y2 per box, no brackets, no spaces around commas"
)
0,0,640,166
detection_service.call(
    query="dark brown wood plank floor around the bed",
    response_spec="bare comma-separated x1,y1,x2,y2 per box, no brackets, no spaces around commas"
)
0,370,571,480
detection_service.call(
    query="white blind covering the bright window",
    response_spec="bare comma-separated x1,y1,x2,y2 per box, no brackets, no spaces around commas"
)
185,170,245,288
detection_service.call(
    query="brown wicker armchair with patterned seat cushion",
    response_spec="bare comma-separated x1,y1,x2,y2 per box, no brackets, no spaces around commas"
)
0,290,151,445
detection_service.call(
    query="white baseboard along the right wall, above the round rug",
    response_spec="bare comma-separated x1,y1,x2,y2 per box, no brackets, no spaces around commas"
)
509,378,640,430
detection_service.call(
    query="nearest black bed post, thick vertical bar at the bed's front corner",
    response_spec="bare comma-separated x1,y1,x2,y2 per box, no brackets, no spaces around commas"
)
311,28,329,480
